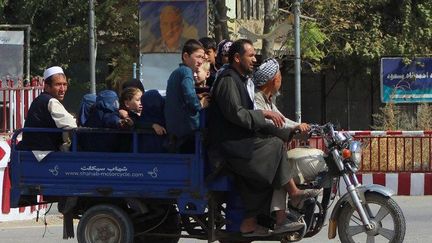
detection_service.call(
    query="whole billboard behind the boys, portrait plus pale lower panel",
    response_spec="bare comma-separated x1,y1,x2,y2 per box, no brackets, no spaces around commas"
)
139,0,208,90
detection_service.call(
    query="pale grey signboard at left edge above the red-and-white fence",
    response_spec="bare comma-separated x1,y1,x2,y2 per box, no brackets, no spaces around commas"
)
0,31,24,81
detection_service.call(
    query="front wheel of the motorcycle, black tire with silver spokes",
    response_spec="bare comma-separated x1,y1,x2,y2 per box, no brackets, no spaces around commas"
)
338,193,406,243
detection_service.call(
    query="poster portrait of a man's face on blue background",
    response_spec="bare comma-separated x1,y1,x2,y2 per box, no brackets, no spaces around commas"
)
140,0,207,53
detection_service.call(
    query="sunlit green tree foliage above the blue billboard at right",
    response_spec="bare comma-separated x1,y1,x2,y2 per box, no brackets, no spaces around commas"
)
303,0,432,64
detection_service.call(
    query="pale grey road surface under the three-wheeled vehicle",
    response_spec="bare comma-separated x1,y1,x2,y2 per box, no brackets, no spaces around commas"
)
0,196,432,243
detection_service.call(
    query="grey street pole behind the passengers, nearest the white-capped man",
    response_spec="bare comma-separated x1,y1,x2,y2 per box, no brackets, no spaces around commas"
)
89,0,96,94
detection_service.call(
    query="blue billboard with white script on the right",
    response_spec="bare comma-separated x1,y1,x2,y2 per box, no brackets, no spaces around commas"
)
380,57,432,103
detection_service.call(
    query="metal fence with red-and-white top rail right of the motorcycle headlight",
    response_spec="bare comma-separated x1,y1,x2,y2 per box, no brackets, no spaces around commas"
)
291,131,432,173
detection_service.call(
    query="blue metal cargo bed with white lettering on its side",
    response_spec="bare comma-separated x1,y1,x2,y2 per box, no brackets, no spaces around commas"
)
10,128,206,214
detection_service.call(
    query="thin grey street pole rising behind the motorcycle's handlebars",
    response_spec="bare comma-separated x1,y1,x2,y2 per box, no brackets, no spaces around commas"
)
294,0,302,122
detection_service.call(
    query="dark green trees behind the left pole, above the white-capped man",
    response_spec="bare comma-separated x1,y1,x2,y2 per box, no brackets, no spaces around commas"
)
0,0,139,87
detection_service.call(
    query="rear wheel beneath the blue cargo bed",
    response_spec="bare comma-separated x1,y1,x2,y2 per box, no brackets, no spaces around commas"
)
77,204,134,243
